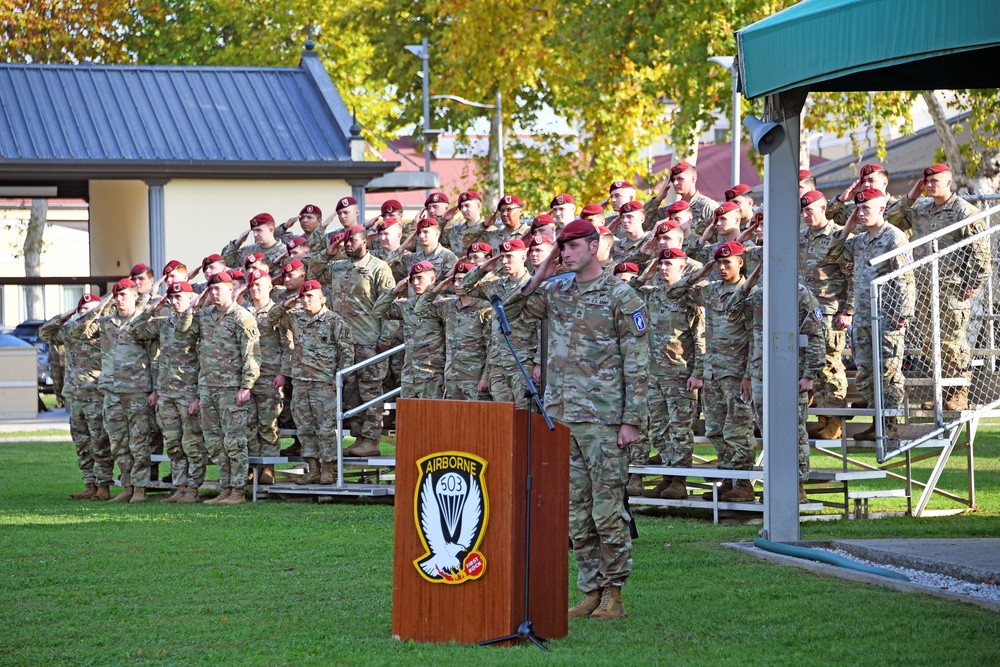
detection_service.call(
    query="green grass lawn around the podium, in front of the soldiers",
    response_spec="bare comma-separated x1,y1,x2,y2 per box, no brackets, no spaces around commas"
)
0,430,1000,667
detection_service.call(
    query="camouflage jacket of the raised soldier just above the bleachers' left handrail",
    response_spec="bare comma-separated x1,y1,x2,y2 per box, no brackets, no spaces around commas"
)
309,252,394,345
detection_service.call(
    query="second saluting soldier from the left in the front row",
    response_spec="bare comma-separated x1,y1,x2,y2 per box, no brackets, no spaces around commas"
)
69,278,155,503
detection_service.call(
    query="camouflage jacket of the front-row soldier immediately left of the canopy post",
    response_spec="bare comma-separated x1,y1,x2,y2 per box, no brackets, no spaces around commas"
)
667,276,753,380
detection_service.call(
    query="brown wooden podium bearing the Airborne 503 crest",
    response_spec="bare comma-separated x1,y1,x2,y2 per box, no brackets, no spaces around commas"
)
392,399,569,644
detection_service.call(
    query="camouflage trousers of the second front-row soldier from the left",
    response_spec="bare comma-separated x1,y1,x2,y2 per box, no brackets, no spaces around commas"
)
104,391,153,487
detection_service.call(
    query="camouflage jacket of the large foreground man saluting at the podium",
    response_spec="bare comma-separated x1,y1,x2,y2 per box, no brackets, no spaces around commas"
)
508,271,649,426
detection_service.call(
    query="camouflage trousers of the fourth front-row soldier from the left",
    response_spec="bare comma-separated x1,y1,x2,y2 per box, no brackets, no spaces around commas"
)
198,387,250,489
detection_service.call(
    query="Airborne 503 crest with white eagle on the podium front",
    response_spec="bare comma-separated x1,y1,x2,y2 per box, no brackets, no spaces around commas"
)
413,452,489,584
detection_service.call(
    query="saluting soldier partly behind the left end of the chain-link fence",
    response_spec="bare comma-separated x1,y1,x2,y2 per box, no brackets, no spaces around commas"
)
827,189,915,440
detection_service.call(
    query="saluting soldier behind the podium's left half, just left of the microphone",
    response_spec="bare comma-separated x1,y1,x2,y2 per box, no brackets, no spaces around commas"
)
413,262,493,401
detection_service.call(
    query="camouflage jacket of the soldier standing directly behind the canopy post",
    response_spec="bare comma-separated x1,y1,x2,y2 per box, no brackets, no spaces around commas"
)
726,282,826,381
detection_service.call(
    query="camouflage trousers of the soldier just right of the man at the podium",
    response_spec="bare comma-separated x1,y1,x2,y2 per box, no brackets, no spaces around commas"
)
648,375,698,468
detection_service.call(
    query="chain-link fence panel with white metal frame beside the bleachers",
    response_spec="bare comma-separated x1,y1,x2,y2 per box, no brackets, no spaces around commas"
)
858,194,1000,463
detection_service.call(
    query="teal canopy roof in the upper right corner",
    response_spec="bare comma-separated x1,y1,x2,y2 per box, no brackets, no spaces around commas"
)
736,0,1000,99
